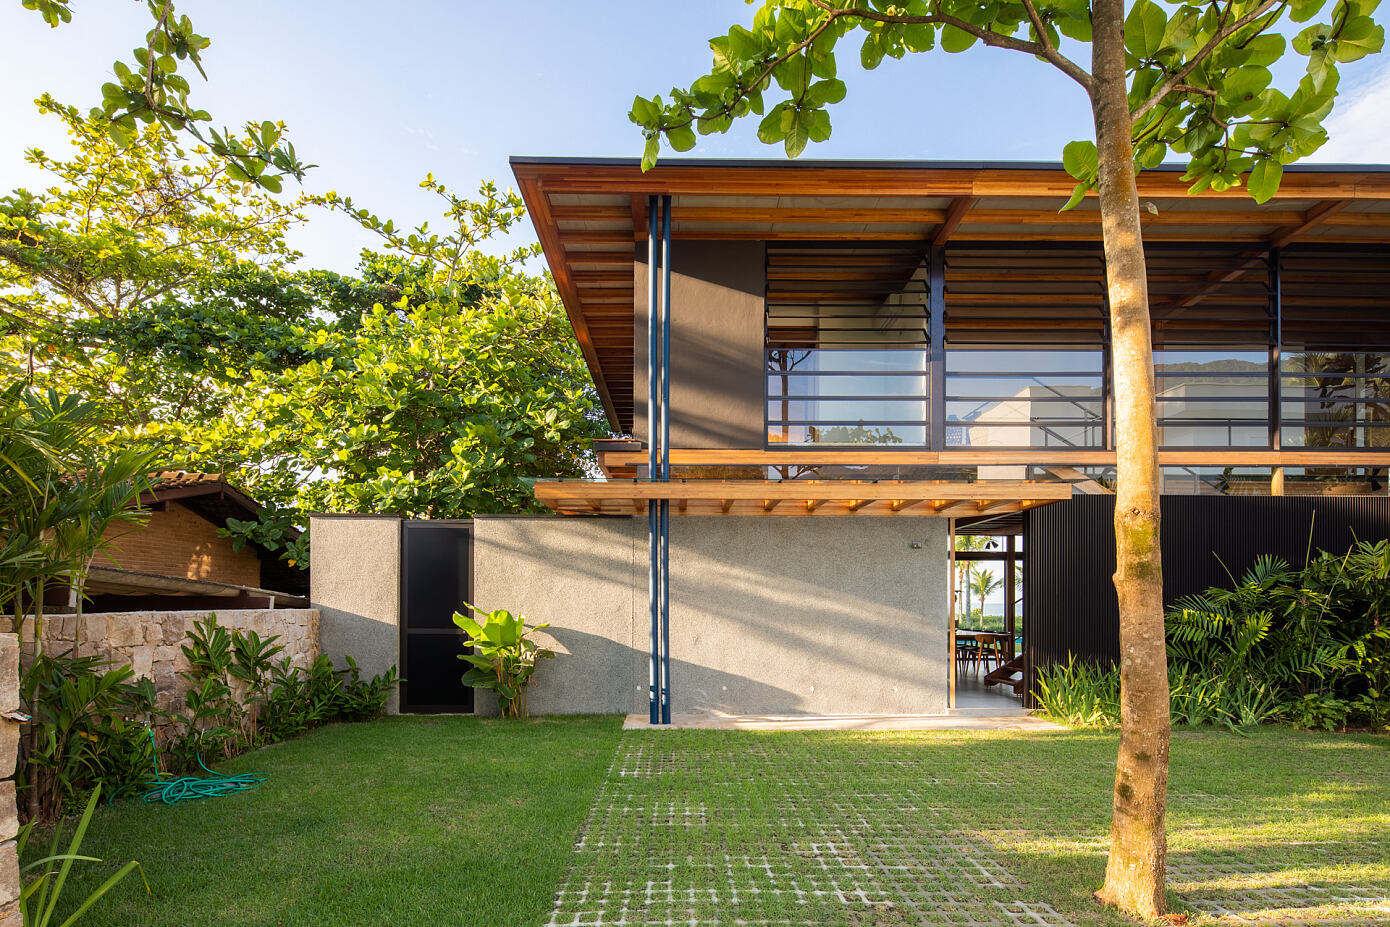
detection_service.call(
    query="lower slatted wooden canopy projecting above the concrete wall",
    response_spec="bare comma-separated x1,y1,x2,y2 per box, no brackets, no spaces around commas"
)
534,479,1072,518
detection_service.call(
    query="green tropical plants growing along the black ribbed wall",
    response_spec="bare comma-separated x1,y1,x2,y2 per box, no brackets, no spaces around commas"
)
1036,541,1390,731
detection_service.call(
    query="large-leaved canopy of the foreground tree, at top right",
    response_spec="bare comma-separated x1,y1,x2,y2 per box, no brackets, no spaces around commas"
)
630,0,1384,204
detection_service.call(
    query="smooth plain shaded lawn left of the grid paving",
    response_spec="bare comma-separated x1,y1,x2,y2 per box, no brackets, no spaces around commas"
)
24,716,621,927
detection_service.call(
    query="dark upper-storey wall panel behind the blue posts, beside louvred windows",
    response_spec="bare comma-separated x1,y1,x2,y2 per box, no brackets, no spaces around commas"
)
632,240,767,449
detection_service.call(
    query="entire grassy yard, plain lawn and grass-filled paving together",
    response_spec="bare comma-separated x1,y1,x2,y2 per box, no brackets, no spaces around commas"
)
32,717,1390,927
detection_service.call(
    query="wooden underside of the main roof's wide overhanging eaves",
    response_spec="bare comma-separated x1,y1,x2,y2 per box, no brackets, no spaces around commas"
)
512,158,1390,432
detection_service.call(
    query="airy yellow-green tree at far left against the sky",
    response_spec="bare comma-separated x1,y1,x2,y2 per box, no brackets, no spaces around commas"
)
0,97,307,421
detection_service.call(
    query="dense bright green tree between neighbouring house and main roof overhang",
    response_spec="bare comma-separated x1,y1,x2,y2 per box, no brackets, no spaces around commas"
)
154,251,602,528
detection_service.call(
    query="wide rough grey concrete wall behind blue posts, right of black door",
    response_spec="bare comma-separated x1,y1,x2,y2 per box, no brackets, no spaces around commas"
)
472,516,948,714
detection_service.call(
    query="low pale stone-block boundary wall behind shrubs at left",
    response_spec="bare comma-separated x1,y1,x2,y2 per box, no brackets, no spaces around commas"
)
38,609,318,710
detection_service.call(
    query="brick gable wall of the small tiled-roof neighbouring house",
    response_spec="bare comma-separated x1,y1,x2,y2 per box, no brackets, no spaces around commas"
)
96,502,261,586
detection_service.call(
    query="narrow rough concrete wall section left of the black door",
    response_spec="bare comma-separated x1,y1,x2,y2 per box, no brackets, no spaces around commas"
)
309,516,400,714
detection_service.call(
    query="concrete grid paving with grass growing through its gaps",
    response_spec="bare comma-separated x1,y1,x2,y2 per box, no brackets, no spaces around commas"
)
548,731,1390,927
